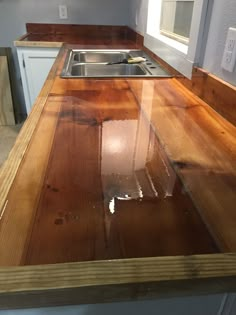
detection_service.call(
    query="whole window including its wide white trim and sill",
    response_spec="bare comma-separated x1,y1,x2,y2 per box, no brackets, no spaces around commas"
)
144,0,211,78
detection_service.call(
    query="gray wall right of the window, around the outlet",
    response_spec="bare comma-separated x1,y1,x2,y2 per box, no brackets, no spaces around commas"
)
203,0,236,85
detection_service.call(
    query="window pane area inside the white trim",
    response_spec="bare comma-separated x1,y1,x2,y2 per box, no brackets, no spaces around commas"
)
160,0,194,44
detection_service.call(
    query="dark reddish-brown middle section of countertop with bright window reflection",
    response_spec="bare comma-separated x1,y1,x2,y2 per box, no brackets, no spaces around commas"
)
25,84,218,264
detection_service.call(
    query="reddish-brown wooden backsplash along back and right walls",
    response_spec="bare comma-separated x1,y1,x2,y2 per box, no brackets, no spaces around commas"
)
15,23,236,125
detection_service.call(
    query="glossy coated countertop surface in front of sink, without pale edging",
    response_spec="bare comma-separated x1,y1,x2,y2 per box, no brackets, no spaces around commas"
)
0,43,235,265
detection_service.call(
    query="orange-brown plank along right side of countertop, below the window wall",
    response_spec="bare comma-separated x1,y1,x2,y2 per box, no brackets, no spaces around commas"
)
130,80,236,251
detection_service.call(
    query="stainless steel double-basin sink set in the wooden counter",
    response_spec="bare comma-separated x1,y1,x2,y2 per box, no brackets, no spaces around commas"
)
61,49,171,78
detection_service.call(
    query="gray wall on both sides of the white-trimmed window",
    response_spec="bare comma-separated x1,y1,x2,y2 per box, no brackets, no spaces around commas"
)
129,0,236,85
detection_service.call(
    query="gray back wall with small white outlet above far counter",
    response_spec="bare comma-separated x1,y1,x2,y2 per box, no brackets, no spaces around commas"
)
0,0,130,121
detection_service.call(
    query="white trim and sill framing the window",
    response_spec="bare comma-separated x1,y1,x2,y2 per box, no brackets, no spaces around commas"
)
144,0,208,78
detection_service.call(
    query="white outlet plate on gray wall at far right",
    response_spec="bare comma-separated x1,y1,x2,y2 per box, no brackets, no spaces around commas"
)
221,27,236,72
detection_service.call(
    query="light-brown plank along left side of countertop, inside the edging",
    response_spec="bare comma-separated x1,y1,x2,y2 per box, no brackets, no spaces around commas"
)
0,99,61,266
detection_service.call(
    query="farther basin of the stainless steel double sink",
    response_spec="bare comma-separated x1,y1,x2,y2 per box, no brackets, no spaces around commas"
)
73,51,130,63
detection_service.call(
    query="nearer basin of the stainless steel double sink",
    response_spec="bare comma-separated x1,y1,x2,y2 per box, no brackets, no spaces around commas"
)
71,64,146,77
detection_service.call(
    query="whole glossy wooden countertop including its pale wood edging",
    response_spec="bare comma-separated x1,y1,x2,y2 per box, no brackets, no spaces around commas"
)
0,40,236,308
